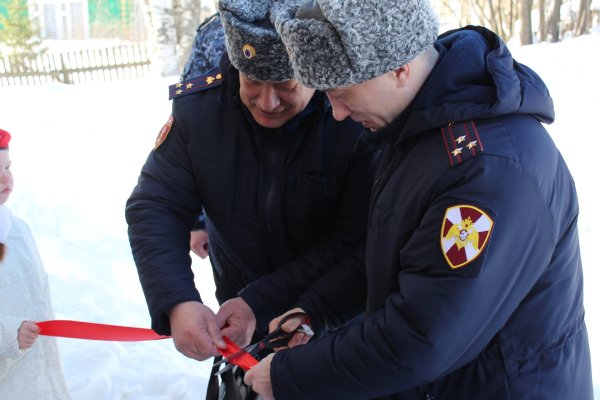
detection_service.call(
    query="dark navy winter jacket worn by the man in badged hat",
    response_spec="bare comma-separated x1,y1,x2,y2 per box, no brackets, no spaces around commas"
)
126,56,380,334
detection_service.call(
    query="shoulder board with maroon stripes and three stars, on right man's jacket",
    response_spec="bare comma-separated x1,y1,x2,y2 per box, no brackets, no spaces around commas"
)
440,121,483,165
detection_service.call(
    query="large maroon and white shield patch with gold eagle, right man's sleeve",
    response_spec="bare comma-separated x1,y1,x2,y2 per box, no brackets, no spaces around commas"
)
440,204,494,269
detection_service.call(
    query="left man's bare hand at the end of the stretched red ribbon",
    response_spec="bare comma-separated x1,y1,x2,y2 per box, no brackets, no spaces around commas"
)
169,301,227,361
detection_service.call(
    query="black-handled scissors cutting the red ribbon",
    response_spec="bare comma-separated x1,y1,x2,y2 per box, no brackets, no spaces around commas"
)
213,311,314,375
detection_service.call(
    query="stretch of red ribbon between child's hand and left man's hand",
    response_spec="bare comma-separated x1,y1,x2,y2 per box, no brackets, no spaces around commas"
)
37,320,170,342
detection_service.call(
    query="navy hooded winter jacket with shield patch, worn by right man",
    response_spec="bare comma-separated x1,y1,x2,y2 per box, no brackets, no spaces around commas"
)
271,27,593,400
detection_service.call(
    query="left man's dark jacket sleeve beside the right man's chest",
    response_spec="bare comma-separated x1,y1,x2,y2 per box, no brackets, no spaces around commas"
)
240,136,380,331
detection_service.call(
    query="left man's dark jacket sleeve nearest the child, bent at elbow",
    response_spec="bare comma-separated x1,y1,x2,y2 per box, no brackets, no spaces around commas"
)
125,108,202,335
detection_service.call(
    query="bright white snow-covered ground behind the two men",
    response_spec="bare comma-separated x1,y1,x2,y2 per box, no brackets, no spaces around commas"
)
0,29,600,400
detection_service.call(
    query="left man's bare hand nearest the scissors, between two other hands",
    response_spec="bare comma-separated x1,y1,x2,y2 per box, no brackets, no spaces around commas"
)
217,297,256,347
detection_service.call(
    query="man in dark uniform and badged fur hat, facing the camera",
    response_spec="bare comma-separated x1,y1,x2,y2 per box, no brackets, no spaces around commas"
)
126,1,379,360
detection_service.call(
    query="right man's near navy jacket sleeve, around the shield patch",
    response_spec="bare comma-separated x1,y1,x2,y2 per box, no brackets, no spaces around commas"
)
271,155,576,400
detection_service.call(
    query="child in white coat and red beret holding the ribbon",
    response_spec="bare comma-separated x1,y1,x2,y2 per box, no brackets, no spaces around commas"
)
0,129,70,400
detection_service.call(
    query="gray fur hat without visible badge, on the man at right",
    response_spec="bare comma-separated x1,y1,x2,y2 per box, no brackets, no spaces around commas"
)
271,0,438,89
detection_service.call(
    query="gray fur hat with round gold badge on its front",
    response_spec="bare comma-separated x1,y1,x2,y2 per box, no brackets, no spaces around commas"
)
219,0,294,82
